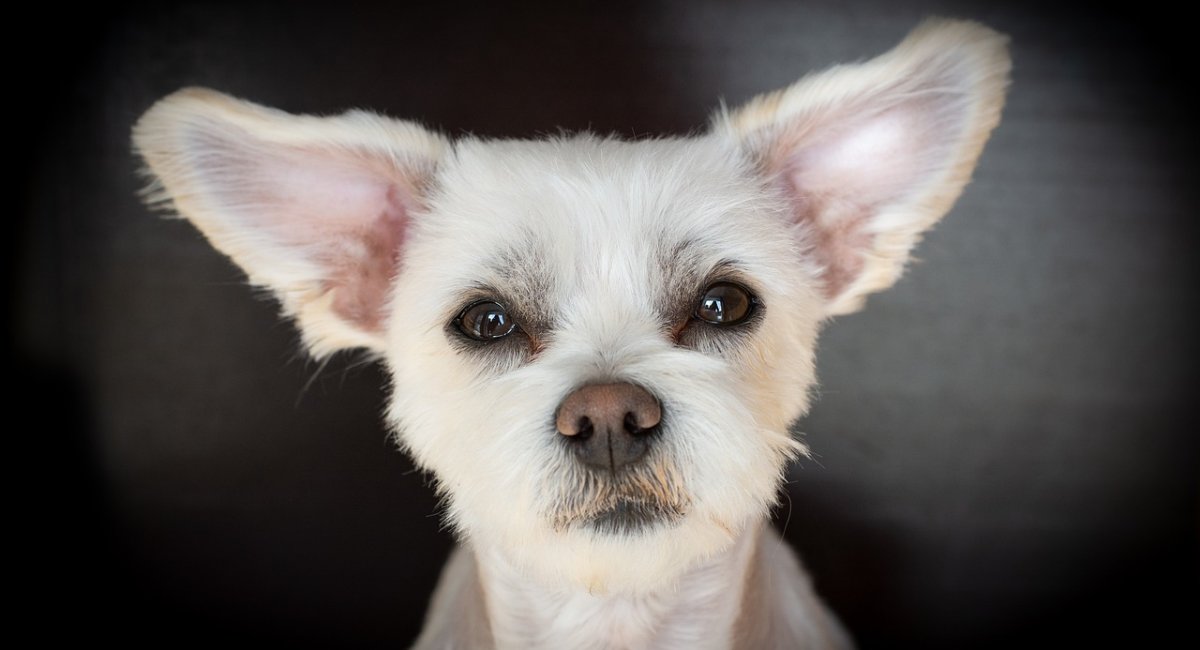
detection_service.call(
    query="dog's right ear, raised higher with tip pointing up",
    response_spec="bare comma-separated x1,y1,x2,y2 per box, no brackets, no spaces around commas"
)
714,20,1010,315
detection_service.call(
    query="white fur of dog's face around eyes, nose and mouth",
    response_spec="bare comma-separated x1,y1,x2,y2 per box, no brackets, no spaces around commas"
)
388,136,821,591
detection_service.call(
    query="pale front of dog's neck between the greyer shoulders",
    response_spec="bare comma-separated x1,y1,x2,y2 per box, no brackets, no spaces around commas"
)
476,526,761,649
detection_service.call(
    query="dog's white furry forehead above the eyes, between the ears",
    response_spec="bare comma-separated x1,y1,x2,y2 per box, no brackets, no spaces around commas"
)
422,136,778,305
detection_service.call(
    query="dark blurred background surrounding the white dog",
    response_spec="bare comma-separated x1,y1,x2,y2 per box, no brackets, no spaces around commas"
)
6,0,1200,648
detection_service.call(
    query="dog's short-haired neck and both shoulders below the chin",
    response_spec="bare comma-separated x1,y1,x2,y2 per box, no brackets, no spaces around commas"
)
415,520,853,650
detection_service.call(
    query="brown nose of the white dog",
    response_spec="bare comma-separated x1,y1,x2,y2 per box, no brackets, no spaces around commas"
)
556,384,662,470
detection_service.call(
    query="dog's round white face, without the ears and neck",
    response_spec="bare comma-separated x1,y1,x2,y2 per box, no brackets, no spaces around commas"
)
384,136,823,589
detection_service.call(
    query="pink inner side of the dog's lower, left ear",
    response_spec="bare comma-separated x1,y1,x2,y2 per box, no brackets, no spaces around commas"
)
194,123,418,332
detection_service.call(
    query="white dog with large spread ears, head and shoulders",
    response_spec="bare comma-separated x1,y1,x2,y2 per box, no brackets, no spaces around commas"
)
133,20,1009,649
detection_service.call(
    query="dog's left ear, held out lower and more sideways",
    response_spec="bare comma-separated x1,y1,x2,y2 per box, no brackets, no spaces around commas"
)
133,89,446,357
